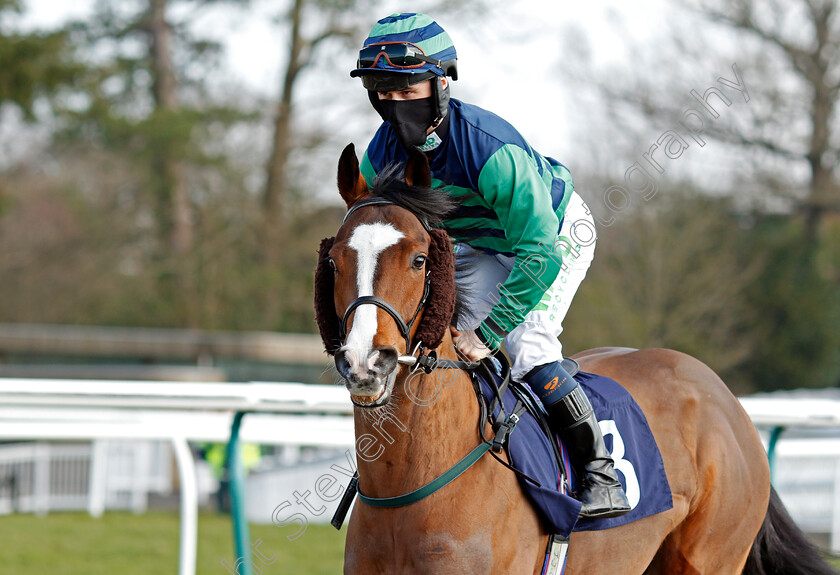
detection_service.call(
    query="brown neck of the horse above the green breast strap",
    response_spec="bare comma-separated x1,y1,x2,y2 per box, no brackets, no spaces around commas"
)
355,334,478,497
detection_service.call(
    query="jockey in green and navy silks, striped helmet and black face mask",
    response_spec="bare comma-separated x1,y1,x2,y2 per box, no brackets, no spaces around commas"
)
350,13,630,517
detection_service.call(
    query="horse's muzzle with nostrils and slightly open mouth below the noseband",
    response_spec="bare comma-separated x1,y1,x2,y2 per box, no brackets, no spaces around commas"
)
335,346,399,407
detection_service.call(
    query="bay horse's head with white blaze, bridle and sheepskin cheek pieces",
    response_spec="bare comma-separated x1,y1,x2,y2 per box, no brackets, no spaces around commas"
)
315,144,455,407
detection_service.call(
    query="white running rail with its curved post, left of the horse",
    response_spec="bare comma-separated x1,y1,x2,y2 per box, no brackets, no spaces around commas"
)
0,378,354,575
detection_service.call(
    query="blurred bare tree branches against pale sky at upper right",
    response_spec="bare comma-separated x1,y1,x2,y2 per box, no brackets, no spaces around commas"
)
580,0,840,239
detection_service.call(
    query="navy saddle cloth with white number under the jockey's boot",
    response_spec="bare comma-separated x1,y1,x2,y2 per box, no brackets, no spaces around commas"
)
476,366,674,537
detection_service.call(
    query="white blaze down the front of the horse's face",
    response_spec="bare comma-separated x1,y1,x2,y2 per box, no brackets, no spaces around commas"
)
344,223,403,371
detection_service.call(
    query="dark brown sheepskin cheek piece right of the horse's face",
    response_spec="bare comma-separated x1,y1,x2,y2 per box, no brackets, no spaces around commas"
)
416,229,455,353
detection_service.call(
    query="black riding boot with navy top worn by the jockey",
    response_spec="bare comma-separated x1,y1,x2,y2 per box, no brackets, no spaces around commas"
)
526,362,630,518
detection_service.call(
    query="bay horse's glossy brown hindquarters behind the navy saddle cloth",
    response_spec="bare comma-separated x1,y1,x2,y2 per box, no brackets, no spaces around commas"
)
571,349,770,575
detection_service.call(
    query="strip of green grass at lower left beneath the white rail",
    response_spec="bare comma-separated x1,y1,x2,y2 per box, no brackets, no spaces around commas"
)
0,513,346,575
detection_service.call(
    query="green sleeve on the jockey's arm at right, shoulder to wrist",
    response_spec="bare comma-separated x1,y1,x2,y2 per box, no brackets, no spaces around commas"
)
478,144,571,349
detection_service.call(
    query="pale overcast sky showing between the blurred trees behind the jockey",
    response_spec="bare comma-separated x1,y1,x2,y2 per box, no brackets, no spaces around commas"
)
16,0,756,209
